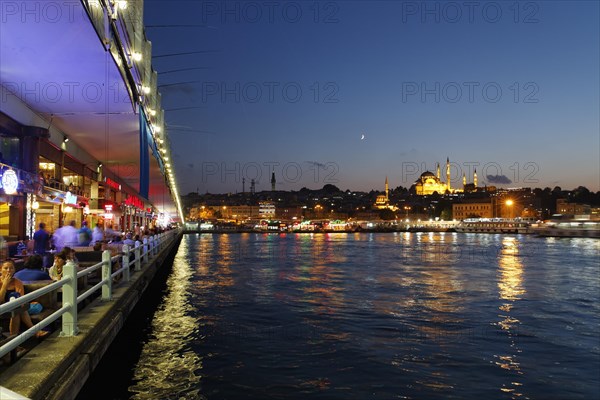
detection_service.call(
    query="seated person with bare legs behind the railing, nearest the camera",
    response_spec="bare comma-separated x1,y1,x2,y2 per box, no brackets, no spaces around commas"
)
0,260,48,338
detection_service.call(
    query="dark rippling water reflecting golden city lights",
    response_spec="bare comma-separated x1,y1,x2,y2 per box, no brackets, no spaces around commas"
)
124,233,600,399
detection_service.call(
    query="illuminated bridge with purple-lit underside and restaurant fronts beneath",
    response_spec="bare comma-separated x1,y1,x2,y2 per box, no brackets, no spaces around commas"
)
0,0,183,240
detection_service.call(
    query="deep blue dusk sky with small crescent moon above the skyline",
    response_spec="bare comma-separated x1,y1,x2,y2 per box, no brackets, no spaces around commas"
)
144,0,600,194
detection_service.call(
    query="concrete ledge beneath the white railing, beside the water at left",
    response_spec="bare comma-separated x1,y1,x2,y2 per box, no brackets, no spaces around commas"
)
0,232,183,400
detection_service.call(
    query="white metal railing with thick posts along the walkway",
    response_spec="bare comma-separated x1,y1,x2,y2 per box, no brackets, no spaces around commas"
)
0,229,179,358
